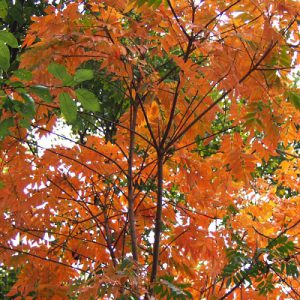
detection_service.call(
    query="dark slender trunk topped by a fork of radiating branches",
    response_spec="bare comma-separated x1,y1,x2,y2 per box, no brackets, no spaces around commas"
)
150,150,164,283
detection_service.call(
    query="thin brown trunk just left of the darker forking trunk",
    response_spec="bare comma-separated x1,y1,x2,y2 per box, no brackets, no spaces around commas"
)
127,104,138,261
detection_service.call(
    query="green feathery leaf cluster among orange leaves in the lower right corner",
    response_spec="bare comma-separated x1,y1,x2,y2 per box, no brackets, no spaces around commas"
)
223,234,299,295
